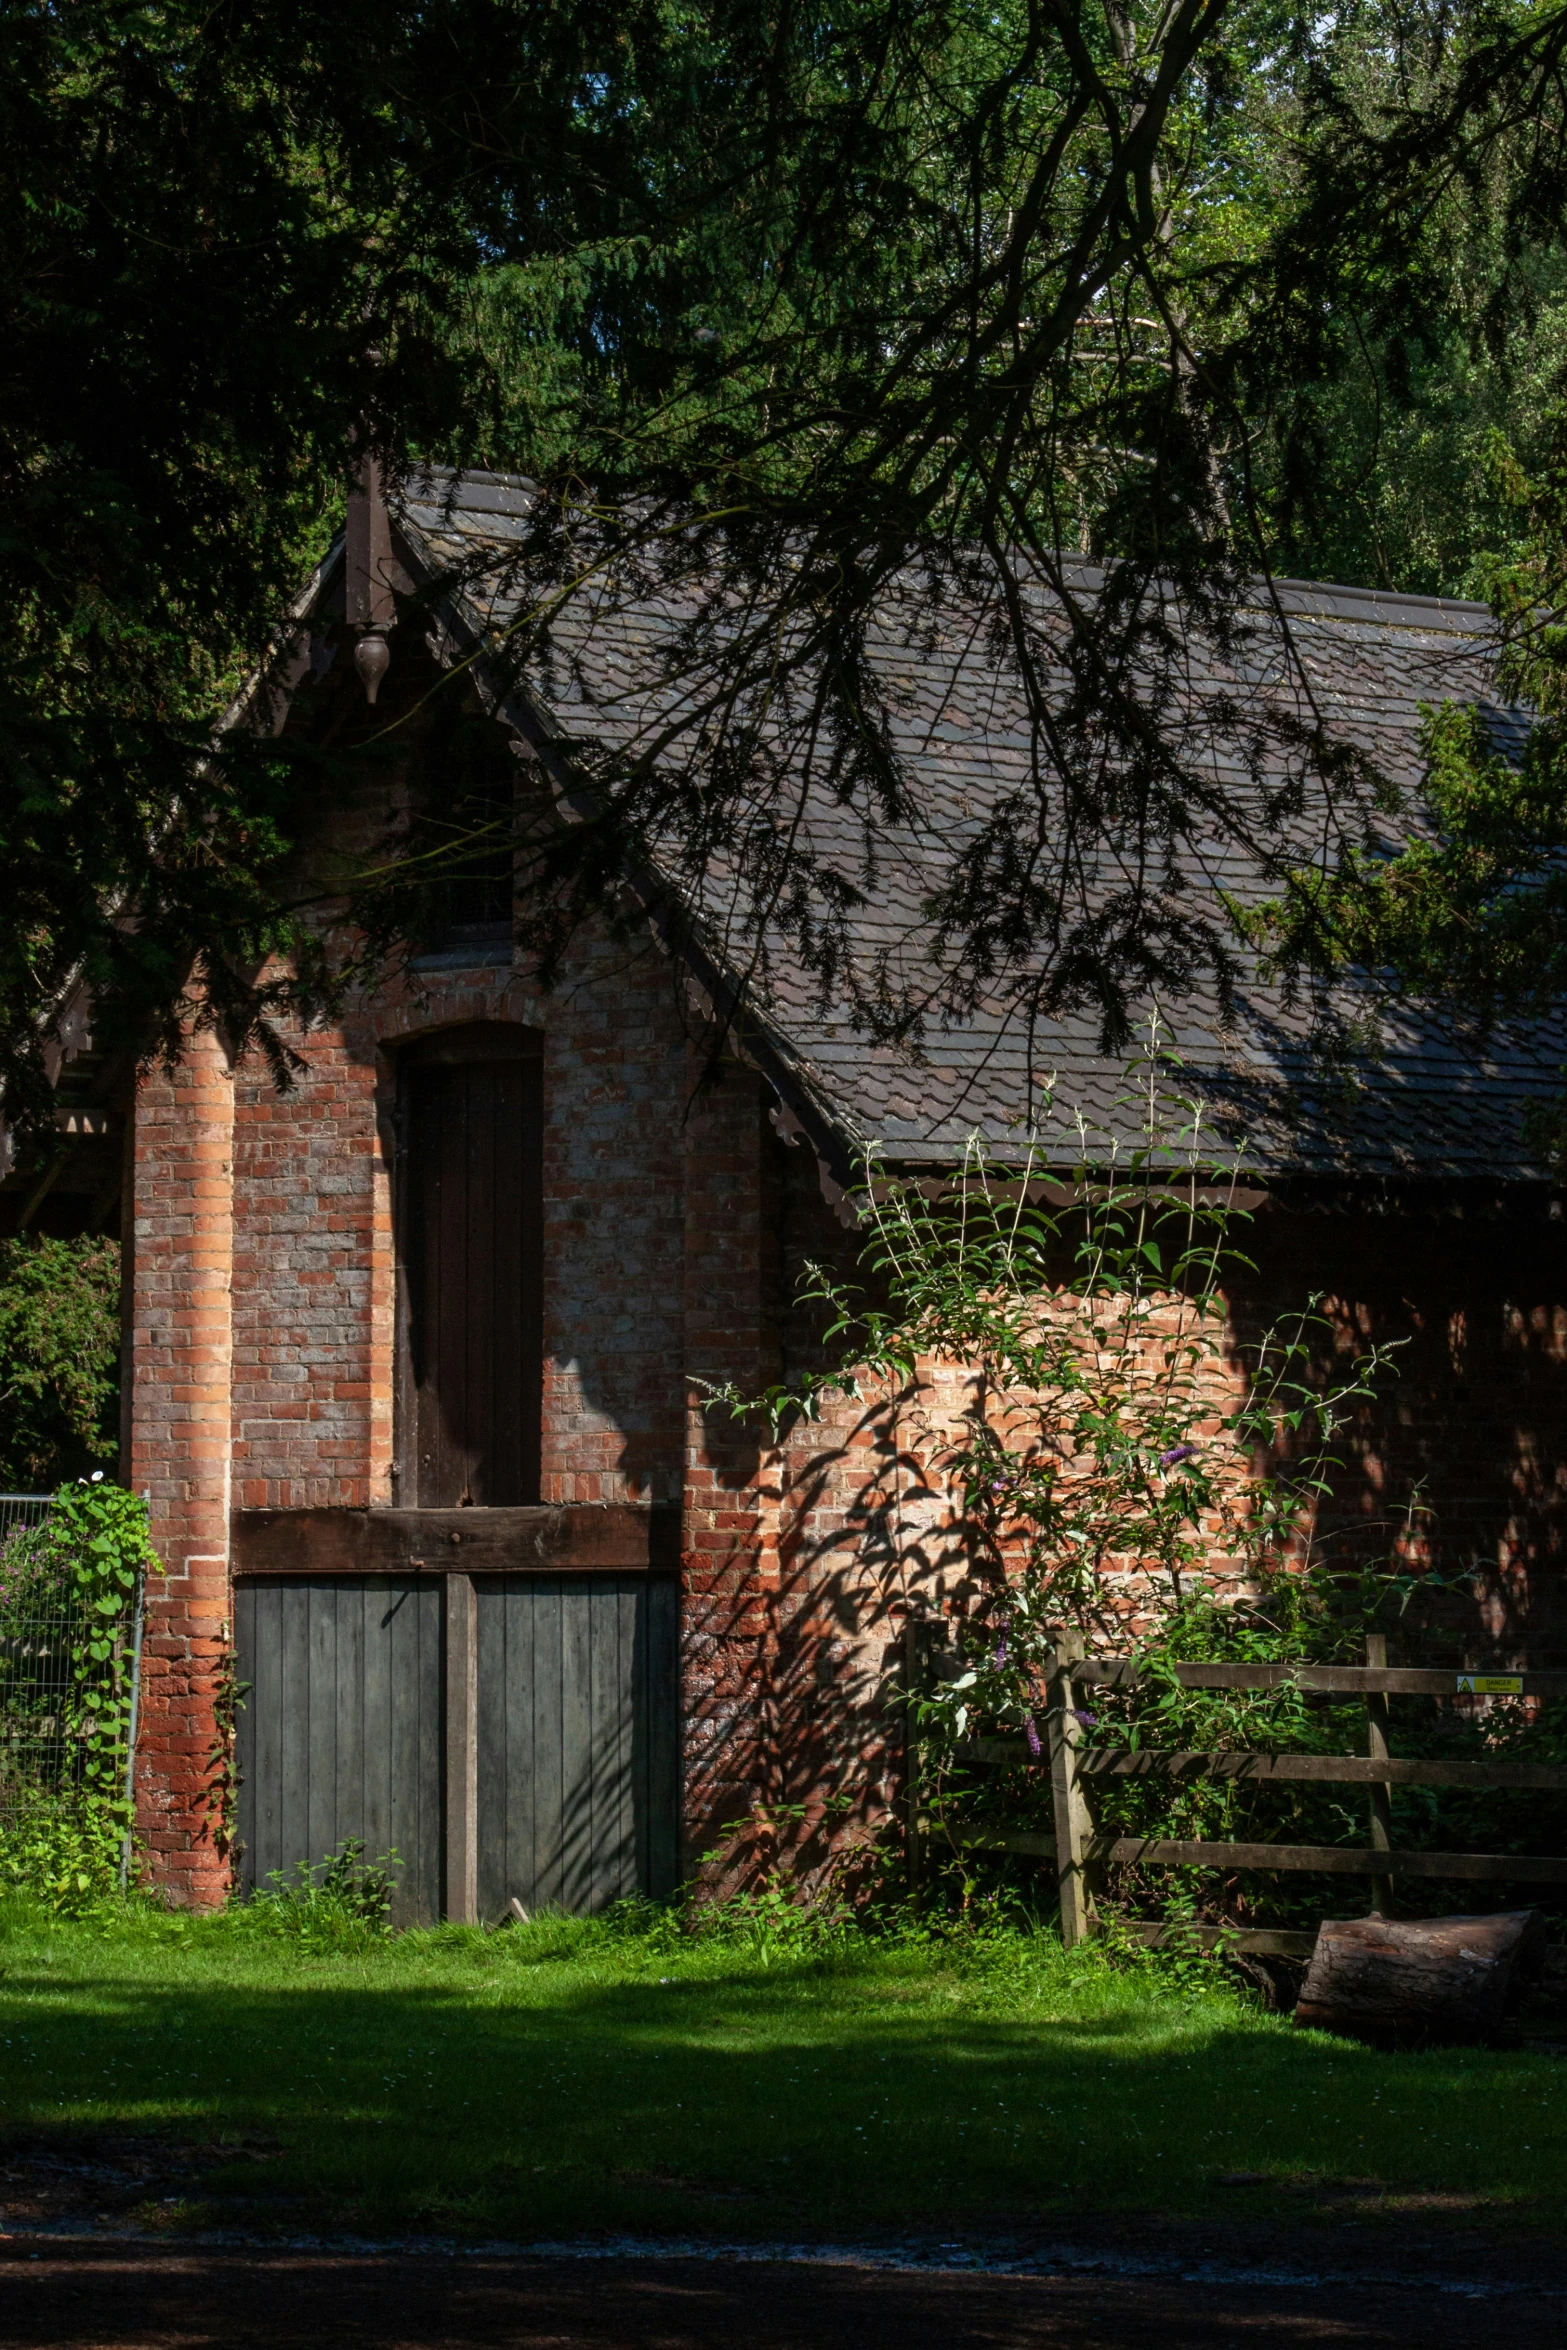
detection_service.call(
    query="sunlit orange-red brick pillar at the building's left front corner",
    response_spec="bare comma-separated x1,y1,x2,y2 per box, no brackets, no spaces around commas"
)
132,1029,235,1908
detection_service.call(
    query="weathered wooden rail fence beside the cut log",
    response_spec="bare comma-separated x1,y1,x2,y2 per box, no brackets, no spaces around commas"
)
904,1629,1567,1958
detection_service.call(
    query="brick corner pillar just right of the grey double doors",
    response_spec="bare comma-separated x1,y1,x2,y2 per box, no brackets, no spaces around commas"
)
681,1058,782,1859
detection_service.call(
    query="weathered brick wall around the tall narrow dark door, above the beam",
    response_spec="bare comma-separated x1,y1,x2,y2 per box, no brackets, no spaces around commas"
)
222,947,684,1509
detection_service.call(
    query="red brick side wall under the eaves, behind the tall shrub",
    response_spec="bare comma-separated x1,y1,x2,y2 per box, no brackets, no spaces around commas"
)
688,1149,1567,1879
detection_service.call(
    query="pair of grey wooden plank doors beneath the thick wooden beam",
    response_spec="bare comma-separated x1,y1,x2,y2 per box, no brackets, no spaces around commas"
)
235,1572,679,1925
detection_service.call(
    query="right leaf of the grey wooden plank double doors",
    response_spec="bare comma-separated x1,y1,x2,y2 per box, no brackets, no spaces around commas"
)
477,1575,679,1920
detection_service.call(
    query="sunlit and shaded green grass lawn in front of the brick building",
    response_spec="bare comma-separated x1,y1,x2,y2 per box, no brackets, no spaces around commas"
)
0,1906,1567,2240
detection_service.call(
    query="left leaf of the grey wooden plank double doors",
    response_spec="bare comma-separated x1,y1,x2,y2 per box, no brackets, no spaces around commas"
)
235,1575,444,1925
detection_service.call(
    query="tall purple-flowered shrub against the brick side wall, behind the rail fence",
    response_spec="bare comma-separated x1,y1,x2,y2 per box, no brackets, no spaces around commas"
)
714,1029,1560,1920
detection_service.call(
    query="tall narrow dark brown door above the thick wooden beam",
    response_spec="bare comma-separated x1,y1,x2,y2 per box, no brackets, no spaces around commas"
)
399,1022,543,1509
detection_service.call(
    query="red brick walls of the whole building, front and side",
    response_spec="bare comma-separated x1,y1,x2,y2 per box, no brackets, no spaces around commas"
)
132,942,1567,1901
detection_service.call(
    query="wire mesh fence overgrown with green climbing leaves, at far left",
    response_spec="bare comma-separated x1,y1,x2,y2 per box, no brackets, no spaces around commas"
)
0,1492,141,1833
